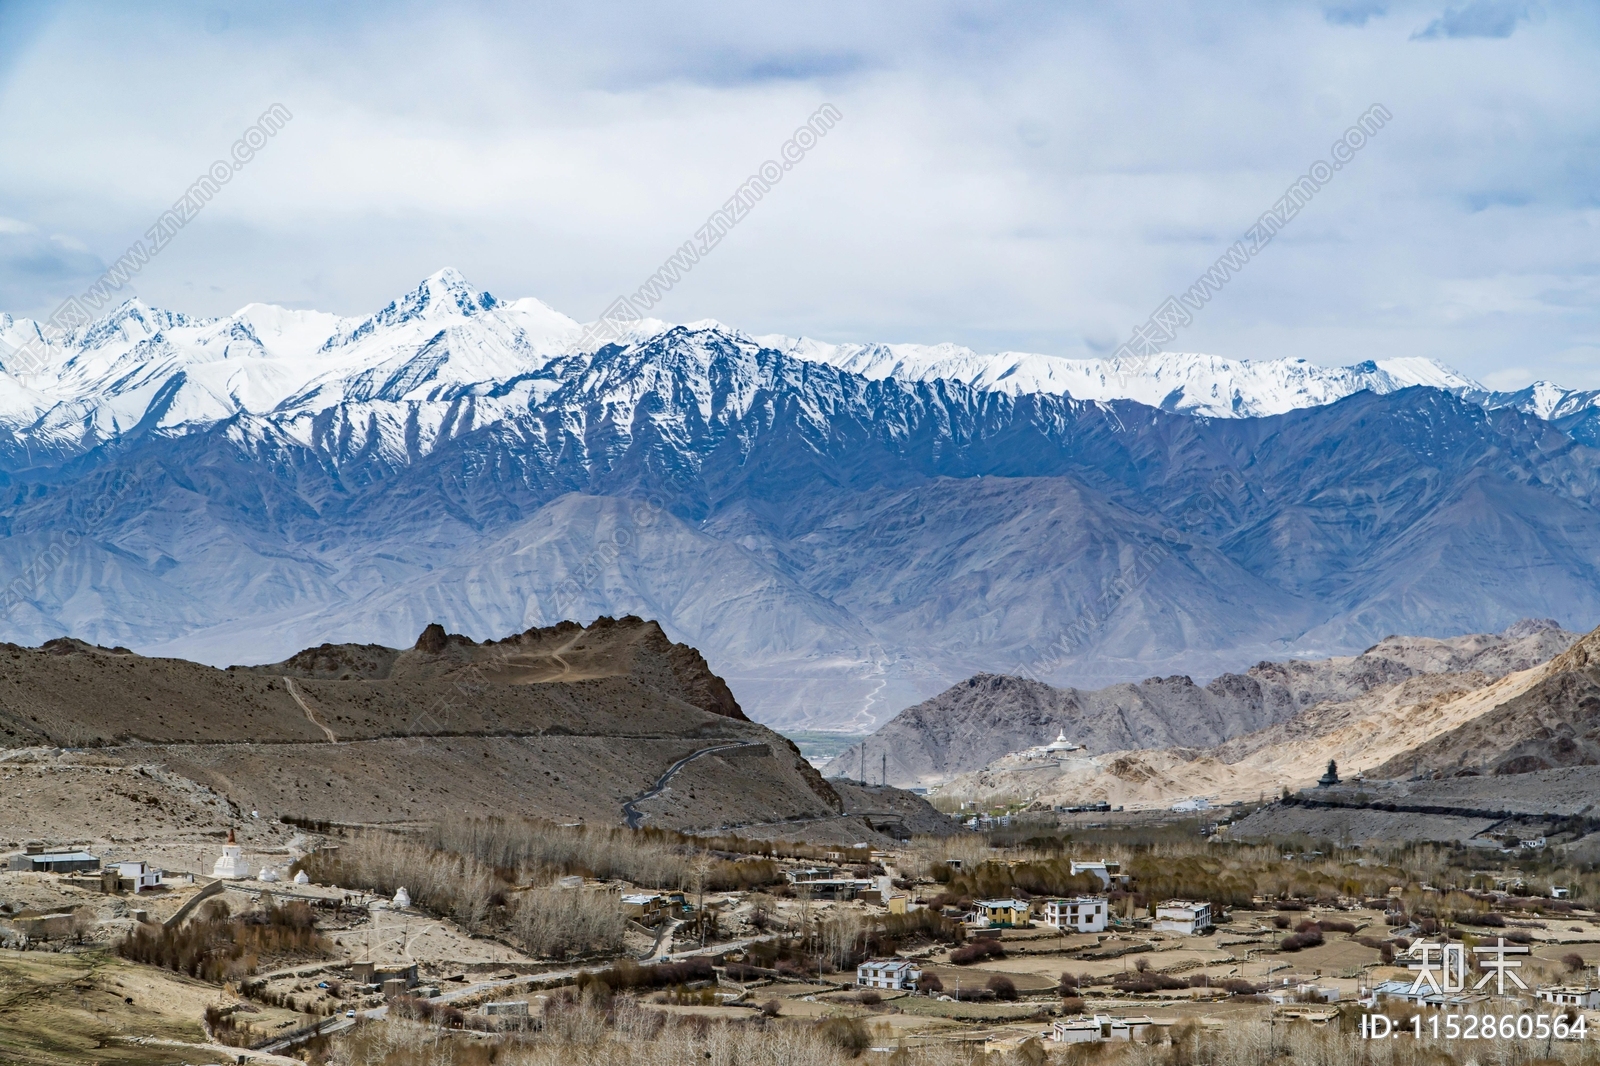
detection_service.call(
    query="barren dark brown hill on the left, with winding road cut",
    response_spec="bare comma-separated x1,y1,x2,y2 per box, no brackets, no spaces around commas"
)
0,618,859,829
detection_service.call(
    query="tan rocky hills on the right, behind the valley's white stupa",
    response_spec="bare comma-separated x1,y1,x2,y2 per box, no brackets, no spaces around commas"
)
915,621,1600,809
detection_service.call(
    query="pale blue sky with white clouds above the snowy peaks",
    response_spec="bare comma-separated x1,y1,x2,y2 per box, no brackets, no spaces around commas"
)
0,0,1600,387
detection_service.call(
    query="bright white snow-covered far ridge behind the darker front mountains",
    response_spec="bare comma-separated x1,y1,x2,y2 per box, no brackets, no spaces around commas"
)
0,269,1597,458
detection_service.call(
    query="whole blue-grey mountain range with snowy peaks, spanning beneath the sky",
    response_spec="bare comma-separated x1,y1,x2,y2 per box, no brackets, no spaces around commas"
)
0,271,1600,726
